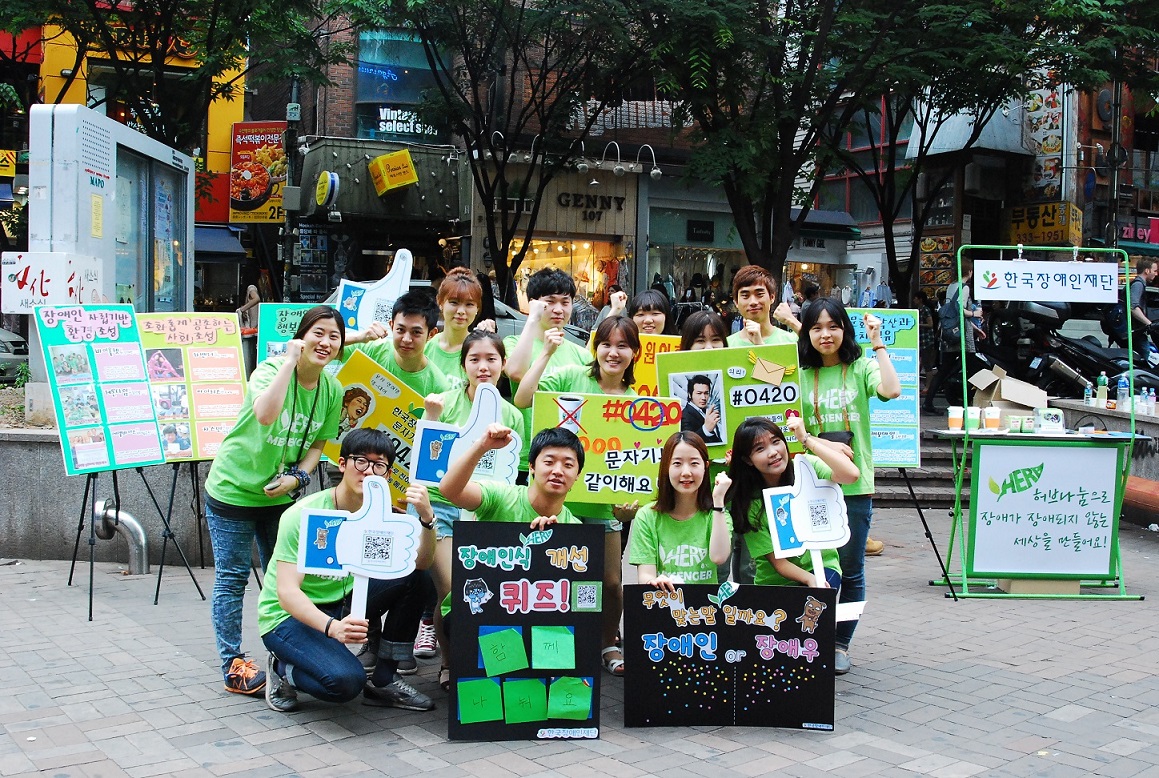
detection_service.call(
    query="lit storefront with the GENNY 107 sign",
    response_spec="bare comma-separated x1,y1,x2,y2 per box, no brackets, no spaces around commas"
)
473,172,636,311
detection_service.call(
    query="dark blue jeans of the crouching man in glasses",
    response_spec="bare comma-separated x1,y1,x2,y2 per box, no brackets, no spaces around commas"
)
262,570,425,703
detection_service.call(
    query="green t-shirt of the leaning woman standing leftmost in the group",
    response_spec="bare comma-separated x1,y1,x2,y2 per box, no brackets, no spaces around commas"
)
205,357,342,508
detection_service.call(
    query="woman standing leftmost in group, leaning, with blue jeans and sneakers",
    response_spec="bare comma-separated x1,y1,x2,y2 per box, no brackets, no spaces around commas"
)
205,305,347,695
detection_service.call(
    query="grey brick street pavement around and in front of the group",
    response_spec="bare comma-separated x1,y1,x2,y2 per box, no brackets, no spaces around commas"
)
0,509,1159,778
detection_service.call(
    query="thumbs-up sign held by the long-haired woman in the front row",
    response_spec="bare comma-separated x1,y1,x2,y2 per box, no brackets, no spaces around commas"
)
763,457,850,581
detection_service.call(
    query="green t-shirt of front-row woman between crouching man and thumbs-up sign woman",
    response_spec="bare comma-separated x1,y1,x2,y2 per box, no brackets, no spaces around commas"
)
628,503,732,583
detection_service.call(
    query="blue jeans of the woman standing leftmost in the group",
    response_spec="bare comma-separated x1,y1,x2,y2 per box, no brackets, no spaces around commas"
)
205,503,287,676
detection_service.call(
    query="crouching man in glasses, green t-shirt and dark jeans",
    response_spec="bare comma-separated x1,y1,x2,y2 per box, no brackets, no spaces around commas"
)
257,429,435,712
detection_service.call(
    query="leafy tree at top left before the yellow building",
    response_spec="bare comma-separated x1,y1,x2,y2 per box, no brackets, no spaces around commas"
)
0,0,349,151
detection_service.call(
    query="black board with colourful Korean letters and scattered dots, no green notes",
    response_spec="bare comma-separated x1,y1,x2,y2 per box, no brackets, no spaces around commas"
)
625,584,837,730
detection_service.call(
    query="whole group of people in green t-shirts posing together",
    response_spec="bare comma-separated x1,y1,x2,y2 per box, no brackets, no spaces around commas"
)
206,266,899,711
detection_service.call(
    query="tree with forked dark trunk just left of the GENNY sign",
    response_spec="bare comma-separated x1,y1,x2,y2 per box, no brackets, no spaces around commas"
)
355,0,642,304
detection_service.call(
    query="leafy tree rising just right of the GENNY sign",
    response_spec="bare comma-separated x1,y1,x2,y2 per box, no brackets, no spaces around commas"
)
641,0,919,278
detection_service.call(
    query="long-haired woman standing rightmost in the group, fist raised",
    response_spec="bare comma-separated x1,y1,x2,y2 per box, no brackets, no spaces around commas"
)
797,297,902,675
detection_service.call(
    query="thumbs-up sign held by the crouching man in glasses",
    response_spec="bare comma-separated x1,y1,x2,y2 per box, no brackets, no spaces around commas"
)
298,475,422,618
